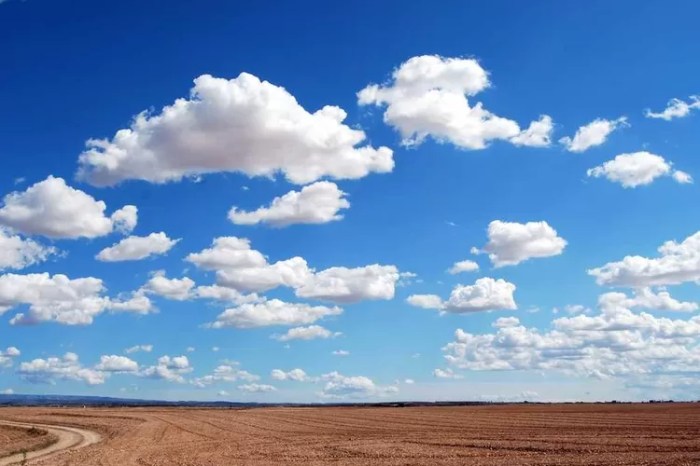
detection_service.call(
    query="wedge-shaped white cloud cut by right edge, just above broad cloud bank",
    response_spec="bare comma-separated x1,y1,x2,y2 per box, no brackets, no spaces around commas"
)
588,231,700,288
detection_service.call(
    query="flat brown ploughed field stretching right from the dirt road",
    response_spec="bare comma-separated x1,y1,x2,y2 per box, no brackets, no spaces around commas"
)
0,403,700,466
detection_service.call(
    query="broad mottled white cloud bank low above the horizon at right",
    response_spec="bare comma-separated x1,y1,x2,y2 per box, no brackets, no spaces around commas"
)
443,292,700,378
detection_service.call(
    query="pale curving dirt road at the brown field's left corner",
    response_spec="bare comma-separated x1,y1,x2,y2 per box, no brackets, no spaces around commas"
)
0,421,100,466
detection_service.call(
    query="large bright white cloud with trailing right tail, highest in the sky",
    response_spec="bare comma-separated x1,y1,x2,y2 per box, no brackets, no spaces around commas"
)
357,55,552,149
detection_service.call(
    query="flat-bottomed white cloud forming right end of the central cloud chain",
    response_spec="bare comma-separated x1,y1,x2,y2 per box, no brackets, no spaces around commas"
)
296,264,401,303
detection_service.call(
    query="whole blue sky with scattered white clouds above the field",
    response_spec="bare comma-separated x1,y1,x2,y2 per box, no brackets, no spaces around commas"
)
0,0,700,402
